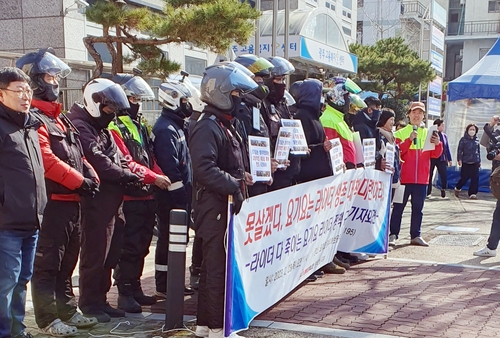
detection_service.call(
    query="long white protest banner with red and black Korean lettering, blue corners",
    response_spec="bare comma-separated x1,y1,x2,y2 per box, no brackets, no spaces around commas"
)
224,170,391,337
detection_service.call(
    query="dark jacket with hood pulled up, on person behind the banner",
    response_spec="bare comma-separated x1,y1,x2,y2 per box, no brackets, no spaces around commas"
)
295,80,333,182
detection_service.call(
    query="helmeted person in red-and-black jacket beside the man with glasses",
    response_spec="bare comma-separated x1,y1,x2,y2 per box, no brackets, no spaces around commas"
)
16,48,99,337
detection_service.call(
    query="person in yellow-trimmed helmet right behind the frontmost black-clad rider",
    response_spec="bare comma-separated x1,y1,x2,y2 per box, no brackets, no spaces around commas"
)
233,54,278,197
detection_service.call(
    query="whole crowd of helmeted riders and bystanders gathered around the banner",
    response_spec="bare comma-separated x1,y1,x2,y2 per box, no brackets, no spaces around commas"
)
0,48,494,338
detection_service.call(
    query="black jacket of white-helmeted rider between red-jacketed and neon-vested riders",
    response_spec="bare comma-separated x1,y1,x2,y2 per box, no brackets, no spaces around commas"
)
68,103,131,185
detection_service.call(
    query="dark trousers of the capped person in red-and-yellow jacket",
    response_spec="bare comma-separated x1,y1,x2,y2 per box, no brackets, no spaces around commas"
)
390,184,427,239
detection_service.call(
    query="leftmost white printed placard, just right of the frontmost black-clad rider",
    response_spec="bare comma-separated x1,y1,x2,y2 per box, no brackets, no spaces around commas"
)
248,136,271,182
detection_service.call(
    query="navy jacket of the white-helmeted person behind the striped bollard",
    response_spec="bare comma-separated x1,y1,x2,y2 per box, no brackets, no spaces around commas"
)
153,109,192,207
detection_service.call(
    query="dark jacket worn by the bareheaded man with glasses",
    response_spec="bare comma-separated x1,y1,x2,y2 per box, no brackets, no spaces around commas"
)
0,103,47,231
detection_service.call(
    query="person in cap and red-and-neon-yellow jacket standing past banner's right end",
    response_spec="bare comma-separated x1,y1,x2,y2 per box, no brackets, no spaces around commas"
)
389,102,443,246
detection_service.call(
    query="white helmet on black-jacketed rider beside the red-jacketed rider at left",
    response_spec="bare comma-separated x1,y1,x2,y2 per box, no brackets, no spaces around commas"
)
83,79,130,117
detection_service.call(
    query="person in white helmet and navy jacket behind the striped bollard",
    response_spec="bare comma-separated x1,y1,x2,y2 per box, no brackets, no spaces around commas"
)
148,80,194,299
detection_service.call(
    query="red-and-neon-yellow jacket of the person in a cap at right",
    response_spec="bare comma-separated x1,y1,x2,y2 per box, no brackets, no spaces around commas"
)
394,125,443,185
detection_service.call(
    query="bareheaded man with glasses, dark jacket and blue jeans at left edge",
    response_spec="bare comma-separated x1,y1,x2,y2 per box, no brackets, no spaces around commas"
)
0,67,46,337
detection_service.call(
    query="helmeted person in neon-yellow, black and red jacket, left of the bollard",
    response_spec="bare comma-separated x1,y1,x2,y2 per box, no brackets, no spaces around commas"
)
108,74,170,313
